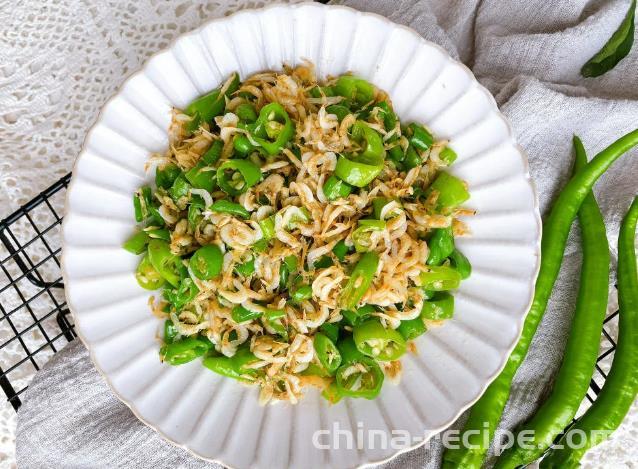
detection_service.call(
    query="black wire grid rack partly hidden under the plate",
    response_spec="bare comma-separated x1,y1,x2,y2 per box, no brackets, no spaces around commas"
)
0,170,618,411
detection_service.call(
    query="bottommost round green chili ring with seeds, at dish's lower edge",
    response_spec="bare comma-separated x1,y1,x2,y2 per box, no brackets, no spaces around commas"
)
336,357,384,399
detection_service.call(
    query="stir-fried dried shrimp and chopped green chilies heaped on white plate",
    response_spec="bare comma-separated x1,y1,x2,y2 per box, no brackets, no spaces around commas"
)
124,64,472,403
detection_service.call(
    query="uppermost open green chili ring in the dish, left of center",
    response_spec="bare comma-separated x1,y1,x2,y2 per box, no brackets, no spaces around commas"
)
253,103,295,155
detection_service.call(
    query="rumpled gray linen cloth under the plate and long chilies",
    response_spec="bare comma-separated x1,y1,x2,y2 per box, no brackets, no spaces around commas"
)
17,0,638,468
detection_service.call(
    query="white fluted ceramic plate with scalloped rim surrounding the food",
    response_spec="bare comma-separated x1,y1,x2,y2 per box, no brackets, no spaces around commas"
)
63,3,540,468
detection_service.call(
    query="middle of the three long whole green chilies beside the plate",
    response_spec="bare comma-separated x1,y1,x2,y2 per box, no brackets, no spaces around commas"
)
495,136,610,468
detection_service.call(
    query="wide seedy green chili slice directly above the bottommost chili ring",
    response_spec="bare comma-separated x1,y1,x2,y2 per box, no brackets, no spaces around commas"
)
352,319,406,361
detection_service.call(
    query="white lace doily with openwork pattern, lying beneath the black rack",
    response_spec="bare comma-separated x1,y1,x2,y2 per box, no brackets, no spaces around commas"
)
0,0,638,469
